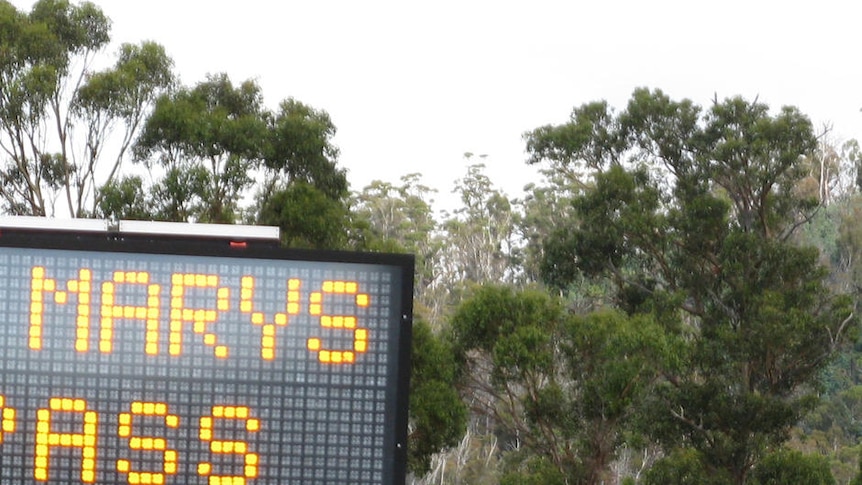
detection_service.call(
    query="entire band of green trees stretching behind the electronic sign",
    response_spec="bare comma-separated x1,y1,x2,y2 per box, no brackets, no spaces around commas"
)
0,0,862,484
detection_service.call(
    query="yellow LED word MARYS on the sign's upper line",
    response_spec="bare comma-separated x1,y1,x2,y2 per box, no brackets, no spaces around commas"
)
28,266,370,364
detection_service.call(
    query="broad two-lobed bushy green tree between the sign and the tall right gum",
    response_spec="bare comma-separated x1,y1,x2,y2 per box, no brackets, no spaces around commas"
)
451,286,672,484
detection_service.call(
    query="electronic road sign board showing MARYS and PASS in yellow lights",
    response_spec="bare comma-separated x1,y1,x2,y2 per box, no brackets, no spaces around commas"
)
0,223,413,485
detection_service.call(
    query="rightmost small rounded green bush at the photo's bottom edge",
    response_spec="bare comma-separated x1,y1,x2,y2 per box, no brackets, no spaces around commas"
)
750,450,835,485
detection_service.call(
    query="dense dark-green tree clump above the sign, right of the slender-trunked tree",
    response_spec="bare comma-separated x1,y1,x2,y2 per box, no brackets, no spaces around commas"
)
134,74,347,224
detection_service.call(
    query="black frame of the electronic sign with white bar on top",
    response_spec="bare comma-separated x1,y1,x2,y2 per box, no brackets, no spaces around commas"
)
0,218,415,485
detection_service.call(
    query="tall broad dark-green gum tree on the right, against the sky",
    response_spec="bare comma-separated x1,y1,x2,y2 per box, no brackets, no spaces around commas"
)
527,89,856,484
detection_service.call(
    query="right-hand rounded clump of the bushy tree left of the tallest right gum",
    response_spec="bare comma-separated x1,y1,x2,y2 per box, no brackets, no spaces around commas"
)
568,311,681,484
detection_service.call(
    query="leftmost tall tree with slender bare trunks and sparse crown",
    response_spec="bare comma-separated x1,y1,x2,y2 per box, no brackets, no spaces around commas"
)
0,0,173,217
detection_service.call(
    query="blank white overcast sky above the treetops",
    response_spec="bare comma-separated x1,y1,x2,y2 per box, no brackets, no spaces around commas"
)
15,0,862,212
